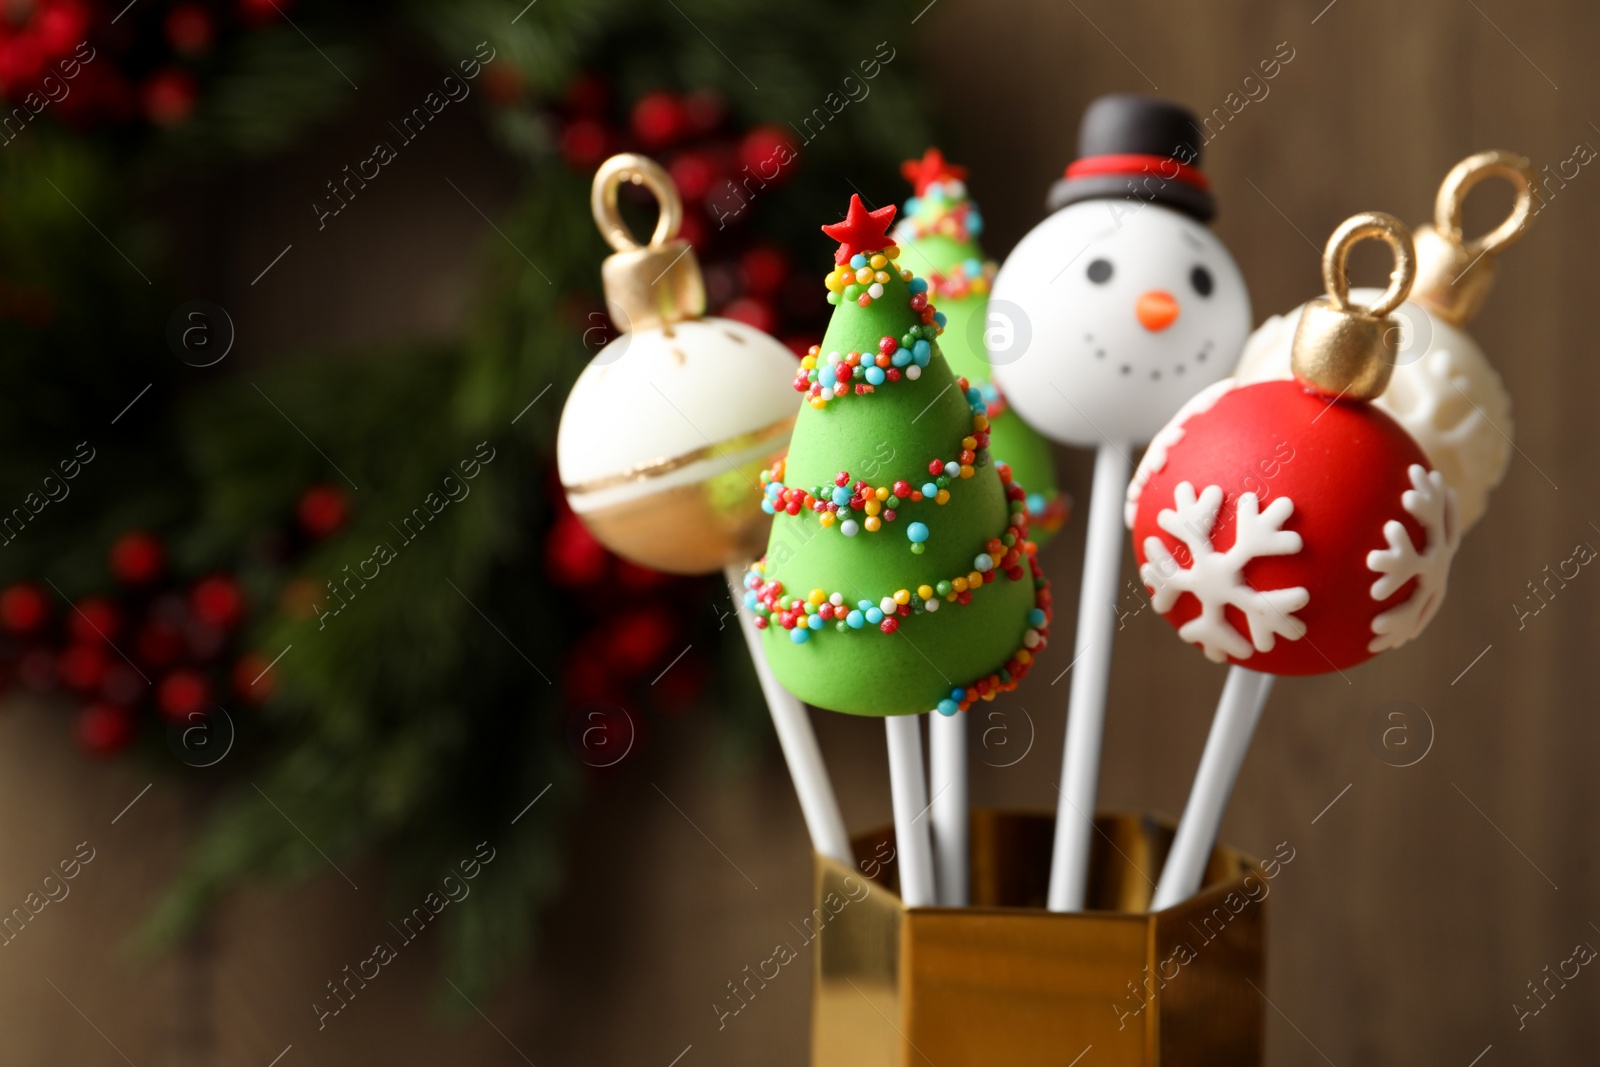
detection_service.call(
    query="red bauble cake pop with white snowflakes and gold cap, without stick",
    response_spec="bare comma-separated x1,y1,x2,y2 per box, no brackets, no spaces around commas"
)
1128,213,1459,675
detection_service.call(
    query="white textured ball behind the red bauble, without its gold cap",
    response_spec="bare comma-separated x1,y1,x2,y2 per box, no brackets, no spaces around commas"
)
1237,290,1515,530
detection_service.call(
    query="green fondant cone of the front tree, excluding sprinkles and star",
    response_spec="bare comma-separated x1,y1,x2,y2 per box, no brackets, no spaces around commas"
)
763,260,1034,715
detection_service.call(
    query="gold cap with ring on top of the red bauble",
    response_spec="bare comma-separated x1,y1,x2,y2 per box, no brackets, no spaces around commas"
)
1290,211,1416,400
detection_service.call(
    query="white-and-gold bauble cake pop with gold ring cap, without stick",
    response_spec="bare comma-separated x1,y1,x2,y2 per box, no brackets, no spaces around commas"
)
555,155,797,574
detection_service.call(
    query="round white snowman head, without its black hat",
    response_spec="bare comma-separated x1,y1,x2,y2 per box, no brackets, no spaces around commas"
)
984,200,1250,448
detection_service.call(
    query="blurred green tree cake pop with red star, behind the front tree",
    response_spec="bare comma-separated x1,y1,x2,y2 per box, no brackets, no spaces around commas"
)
894,149,1067,544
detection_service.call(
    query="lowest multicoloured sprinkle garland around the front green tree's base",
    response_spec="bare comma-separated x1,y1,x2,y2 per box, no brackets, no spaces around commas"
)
744,464,1051,715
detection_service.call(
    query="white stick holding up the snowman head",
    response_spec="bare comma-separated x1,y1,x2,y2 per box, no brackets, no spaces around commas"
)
1048,442,1130,912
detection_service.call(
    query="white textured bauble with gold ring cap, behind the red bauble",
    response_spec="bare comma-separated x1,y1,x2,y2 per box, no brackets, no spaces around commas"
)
1237,152,1534,530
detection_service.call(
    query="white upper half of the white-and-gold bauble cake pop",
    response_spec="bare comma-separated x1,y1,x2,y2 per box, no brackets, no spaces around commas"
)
555,318,800,510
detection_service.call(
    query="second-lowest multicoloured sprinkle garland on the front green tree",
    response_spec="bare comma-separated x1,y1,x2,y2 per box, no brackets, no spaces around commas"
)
762,378,989,555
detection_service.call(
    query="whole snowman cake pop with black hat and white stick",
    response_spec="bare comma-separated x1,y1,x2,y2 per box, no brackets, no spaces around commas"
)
987,96,1250,912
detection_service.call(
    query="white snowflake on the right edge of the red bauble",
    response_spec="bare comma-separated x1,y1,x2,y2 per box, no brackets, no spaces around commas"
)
1366,464,1461,653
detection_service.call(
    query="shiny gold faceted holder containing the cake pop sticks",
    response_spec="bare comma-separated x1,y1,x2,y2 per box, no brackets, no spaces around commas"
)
803,809,1267,1067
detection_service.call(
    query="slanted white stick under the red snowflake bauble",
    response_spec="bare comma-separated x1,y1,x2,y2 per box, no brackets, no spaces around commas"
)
1150,667,1272,912
